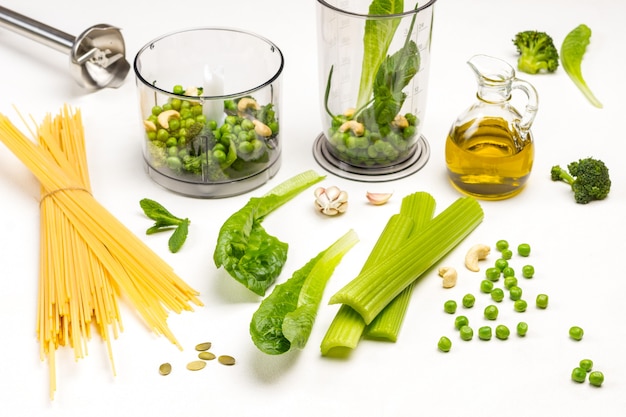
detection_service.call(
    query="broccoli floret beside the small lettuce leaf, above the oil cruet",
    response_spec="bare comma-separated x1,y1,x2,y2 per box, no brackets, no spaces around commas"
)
513,30,559,74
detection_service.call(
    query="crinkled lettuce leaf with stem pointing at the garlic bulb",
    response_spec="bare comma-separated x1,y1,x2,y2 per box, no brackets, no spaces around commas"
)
213,170,325,296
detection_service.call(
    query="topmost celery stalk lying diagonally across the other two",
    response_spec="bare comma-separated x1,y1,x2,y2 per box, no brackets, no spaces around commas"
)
330,197,484,324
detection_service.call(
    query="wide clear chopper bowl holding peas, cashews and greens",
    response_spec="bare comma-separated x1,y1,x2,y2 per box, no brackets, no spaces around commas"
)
134,28,284,198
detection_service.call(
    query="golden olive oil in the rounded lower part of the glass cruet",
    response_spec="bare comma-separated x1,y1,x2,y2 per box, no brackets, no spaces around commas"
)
446,117,534,200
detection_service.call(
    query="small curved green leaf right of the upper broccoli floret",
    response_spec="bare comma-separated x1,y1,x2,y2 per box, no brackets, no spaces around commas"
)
561,24,602,108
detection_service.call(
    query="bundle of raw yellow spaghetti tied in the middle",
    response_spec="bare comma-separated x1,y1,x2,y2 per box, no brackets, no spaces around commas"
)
0,107,202,397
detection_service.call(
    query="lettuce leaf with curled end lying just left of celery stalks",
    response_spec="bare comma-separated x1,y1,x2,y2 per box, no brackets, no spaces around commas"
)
250,230,359,355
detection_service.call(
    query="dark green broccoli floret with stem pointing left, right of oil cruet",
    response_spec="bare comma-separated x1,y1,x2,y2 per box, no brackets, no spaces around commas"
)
550,158,611,204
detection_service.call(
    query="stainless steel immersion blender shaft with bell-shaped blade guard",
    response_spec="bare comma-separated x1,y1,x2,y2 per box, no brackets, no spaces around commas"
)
0,6,130,89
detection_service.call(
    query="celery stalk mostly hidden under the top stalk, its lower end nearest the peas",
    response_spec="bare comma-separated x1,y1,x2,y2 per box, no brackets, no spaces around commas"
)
365,195,435,342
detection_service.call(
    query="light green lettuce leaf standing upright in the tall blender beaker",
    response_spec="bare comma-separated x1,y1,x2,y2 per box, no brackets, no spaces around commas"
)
357,0,404,108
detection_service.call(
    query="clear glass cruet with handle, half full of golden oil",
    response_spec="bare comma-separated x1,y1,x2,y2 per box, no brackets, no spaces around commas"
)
445,55,538,200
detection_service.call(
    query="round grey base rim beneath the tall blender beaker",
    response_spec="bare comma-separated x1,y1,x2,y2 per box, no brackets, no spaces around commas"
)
313,133,430,182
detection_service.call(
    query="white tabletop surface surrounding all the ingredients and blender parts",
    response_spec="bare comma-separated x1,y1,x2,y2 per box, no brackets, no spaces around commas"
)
0,0,626,417
